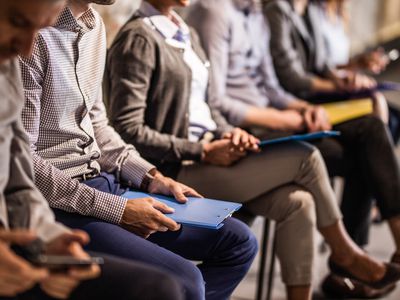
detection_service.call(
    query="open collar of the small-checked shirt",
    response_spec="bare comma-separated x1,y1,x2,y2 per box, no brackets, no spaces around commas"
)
53,7,96,32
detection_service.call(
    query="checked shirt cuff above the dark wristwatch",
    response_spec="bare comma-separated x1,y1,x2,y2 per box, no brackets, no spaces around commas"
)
121,155,155,188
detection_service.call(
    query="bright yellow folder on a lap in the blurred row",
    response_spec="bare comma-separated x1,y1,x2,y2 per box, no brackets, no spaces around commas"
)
322,98,373,125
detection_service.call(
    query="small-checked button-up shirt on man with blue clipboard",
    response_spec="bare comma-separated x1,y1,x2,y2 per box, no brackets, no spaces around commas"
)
20,8,154,223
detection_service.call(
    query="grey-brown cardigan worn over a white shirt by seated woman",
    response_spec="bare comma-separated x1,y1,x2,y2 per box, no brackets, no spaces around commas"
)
106,14,232,176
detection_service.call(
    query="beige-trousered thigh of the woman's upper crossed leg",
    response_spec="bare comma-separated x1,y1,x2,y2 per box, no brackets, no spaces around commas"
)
178,142,314,203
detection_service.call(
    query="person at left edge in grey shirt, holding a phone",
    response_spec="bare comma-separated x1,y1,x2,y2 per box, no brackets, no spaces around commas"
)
0,0,183,300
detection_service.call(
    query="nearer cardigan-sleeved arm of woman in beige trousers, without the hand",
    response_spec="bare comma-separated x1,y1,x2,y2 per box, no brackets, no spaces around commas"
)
108,34,202,162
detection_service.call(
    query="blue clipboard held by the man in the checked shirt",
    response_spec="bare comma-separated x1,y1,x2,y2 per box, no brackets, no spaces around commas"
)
122,191,242,229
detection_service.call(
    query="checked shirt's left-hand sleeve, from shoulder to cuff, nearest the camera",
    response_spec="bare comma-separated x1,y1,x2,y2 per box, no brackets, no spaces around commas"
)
20,36,126,224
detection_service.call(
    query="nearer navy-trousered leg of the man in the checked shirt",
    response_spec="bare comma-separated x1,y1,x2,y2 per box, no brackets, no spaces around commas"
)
55,210,205,299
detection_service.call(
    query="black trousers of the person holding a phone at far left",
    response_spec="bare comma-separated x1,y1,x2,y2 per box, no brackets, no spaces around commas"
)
0,253,184,300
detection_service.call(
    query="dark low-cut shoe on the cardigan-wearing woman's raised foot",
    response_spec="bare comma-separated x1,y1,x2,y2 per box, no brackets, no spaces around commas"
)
329,260,400,290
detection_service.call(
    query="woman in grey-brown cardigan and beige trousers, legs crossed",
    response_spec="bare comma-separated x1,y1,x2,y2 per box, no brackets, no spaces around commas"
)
106,0,400,299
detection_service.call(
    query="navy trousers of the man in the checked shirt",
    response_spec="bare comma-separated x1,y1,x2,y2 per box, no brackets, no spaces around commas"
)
55,173,257,300
